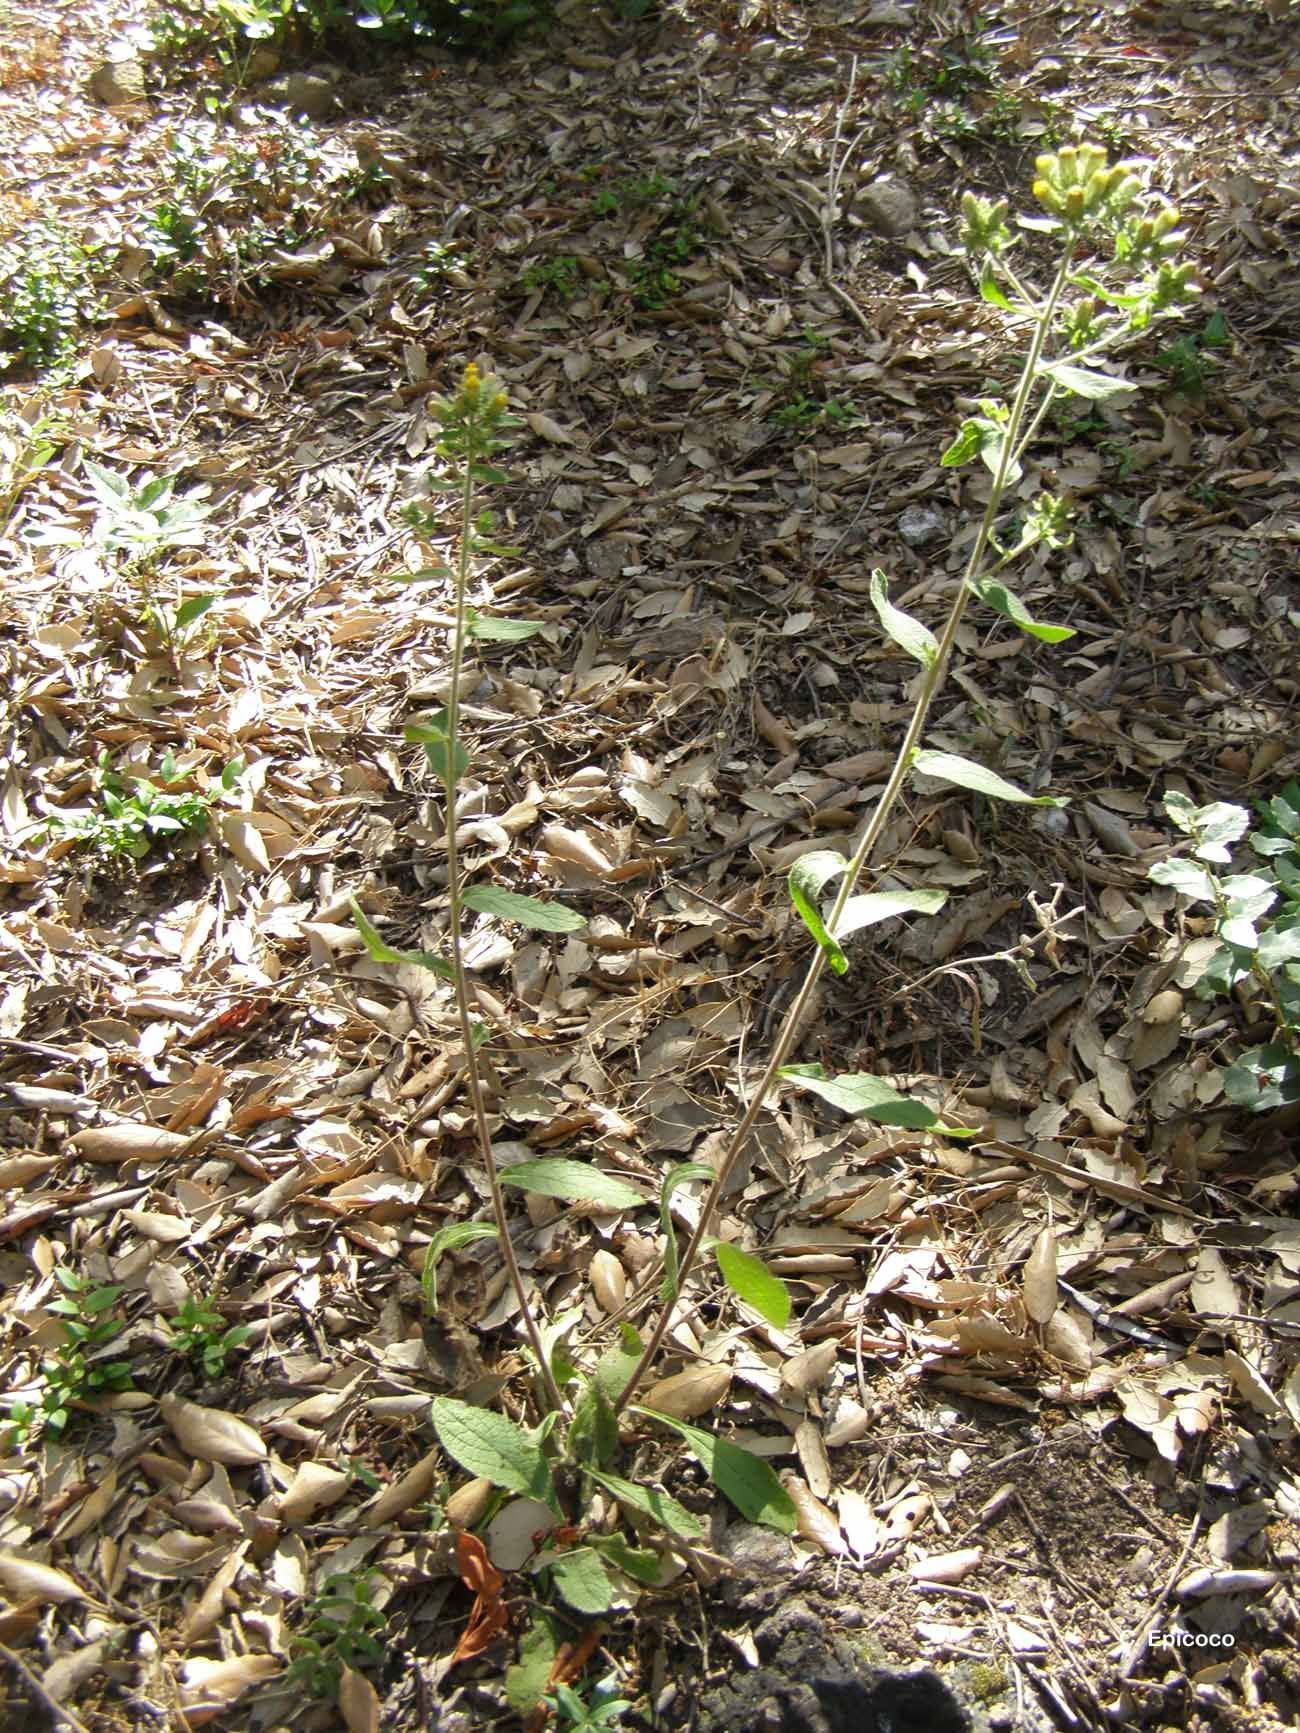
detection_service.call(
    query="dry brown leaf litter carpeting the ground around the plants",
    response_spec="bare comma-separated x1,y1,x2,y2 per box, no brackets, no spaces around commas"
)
0,5,1300,1728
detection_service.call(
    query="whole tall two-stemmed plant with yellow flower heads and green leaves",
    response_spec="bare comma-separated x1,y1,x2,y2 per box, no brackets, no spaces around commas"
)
343,146,1194,1712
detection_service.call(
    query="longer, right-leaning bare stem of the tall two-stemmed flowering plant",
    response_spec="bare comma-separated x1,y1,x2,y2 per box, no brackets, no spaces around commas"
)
614,237,1073,1414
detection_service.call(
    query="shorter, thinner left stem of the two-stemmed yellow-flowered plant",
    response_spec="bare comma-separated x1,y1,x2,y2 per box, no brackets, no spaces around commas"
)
442,449,565,1412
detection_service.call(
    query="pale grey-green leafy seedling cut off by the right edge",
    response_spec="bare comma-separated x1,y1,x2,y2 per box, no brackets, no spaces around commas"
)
1147,782,1300,1113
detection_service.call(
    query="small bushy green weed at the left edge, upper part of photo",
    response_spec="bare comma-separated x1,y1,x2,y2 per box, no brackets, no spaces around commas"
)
0,222,101,373
